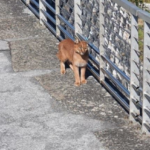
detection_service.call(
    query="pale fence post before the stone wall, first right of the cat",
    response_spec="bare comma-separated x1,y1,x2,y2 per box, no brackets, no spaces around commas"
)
99,0,105,81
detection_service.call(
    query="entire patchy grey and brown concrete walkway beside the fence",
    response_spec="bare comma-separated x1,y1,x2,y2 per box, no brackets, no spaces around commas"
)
0,0,150,150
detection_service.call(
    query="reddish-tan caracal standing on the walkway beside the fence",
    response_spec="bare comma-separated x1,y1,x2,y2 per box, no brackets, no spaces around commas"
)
57,39,89,86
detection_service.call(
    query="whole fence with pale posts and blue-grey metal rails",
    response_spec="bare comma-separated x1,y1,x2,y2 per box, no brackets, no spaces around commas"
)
22,0,150,134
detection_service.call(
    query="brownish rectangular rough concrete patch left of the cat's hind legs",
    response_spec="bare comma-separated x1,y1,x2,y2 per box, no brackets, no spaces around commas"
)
10,38,59,71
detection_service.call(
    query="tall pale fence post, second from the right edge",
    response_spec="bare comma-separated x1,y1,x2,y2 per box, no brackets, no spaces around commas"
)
129,14,140,122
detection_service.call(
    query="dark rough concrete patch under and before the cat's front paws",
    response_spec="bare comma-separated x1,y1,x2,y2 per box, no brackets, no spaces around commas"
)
36,69,127,126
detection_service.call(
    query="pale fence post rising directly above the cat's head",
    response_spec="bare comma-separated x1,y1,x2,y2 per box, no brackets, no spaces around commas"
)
74,0,82,39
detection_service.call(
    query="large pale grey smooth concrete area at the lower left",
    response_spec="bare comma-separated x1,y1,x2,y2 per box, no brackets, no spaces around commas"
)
0,70,110,150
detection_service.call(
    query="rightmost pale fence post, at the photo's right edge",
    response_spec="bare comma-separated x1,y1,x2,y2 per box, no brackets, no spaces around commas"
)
142,22,150,135
